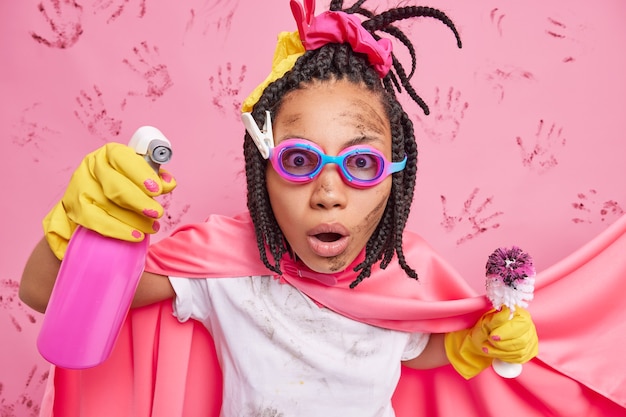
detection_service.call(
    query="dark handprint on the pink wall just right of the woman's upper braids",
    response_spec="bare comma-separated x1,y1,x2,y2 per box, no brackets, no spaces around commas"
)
415,87,469,143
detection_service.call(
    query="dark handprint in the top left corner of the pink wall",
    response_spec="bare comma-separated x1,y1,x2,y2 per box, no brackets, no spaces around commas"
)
30,0,83,49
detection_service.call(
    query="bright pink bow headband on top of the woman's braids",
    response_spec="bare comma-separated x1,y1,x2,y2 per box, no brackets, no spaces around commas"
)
290,0,392,78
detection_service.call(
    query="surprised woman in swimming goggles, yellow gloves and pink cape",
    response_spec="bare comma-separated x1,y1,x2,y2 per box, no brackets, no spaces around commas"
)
20,0,537,417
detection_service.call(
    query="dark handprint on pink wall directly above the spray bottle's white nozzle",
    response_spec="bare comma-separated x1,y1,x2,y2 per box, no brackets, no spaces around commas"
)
122,41,174,101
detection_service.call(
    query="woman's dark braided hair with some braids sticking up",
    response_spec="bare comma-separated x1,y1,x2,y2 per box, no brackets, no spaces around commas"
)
244,0,461,288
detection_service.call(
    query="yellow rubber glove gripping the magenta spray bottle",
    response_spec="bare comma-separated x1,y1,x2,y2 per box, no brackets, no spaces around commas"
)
43,143,176,260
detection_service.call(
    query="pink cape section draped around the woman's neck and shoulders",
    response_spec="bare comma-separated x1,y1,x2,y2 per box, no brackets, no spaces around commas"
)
145,212,489,333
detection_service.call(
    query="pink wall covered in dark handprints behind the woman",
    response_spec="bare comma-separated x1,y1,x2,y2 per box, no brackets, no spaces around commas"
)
0,0,626,417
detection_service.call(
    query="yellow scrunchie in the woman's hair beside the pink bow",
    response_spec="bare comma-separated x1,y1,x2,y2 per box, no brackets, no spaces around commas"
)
241,31,304,113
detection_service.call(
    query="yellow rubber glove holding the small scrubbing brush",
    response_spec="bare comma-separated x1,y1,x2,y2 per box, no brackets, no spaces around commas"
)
445,307,539,379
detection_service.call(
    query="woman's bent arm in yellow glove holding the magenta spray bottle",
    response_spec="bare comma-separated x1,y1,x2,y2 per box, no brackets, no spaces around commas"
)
19,143,176,312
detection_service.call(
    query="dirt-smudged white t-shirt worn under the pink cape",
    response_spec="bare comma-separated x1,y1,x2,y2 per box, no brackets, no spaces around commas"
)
170,276,429,417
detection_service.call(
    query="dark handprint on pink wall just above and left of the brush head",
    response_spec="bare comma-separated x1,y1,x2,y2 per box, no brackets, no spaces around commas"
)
440,188,504,245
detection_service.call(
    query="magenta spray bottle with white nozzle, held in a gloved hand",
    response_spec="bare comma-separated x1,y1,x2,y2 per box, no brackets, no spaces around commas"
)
37,126,172,369
